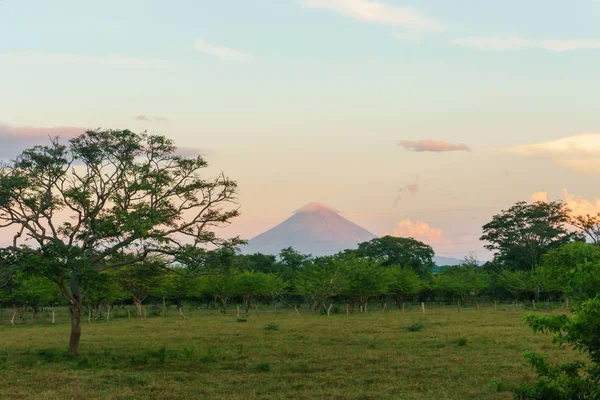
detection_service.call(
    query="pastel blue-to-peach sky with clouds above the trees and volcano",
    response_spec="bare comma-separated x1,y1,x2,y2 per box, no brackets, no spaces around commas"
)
0,0,600,260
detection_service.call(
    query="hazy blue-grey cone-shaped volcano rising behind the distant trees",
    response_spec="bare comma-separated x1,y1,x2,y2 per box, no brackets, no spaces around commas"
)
241,203,377,256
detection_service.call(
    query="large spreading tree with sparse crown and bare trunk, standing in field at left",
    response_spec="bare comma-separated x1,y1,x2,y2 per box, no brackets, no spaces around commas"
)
0,130,240,355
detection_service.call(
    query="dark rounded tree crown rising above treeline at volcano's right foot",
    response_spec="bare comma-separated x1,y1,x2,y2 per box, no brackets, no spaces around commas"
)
357,236,435,277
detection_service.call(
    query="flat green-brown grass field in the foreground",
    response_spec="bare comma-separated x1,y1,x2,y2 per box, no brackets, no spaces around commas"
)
0,306,577,400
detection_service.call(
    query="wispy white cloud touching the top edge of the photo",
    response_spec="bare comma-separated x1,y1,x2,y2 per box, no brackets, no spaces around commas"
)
303,0,445,33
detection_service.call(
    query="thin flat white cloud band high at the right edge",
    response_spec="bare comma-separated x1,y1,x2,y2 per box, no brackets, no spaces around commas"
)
450,36,600,53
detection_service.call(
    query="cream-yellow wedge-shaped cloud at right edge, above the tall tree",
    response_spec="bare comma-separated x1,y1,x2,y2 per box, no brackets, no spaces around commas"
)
504,133,600,175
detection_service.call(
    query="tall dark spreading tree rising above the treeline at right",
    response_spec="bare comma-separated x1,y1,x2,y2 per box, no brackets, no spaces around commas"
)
481,201,580,270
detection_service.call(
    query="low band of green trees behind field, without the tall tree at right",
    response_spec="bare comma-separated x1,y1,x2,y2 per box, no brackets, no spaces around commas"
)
0,236,600,318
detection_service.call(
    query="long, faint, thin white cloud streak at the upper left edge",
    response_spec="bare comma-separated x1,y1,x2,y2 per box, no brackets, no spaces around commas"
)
0,51,172,68
